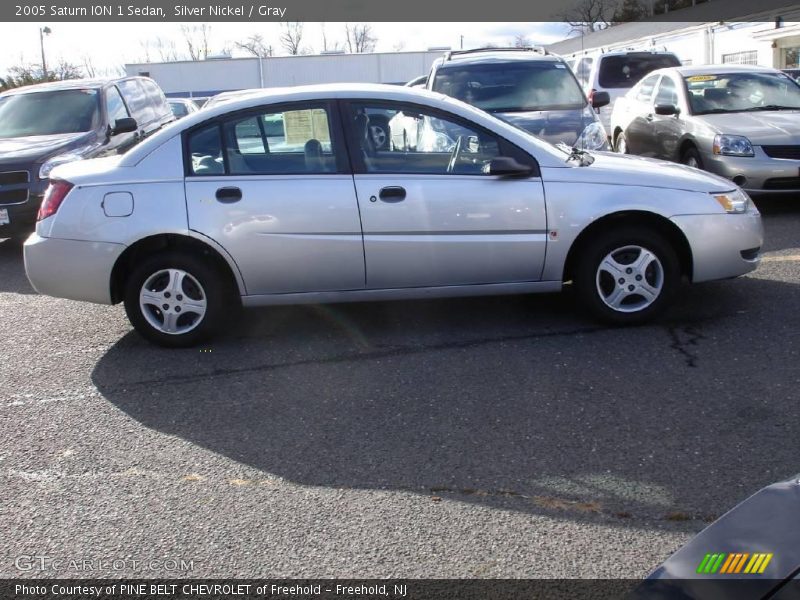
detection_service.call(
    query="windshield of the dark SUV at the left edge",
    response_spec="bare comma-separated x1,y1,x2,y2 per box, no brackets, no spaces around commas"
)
0,89,100,138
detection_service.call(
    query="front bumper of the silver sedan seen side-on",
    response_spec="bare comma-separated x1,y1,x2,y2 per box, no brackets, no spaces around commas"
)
672,208,764,282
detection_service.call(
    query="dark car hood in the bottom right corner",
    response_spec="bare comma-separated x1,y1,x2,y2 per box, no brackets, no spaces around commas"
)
632,475,800,600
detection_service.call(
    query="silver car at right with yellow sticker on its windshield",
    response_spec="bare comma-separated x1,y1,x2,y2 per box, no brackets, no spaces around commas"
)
611,65,800,194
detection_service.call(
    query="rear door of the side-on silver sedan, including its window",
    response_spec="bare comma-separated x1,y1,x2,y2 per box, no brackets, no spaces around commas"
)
185,102,365,294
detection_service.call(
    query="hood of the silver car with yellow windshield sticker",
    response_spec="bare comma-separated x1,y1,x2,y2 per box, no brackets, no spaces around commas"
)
697,110,800,146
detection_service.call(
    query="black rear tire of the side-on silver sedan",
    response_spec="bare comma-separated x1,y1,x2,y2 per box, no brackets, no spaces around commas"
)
124,251,234,348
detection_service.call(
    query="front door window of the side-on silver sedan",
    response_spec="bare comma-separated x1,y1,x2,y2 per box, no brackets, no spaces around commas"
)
346,103,532,175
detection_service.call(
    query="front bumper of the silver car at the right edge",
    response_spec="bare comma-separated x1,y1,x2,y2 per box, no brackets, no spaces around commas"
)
703,146,800,195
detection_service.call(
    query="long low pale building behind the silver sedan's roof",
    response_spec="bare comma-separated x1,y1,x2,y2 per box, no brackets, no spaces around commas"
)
125,50,442,97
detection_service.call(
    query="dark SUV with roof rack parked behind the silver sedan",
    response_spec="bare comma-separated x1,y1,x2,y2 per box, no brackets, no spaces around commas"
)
390,47,608,150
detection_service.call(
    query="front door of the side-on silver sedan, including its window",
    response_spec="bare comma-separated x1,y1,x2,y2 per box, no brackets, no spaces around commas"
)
342,101,547,289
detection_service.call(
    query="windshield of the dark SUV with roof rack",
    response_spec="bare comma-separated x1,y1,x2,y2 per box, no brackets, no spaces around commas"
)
433,62,586,112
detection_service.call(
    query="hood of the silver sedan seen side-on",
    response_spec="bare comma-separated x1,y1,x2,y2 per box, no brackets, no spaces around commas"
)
551,152,736,192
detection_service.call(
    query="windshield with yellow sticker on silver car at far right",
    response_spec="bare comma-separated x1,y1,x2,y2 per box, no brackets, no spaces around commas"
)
684,72,800,115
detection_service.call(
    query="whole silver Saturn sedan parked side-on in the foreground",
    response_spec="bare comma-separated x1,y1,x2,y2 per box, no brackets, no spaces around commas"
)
25,85,762,346
